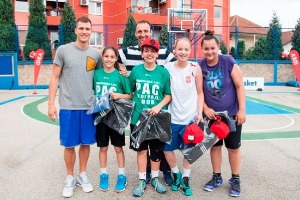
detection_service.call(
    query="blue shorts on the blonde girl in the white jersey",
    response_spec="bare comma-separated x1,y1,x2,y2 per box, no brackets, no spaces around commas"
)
164,124,186,151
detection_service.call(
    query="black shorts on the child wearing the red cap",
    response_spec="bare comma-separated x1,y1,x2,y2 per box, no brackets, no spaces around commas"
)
130,124,166,151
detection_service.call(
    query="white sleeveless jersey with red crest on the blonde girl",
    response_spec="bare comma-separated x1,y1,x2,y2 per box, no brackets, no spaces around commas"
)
164,62,199,125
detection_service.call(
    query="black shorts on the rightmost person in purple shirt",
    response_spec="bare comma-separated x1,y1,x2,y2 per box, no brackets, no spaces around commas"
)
214,125,242,149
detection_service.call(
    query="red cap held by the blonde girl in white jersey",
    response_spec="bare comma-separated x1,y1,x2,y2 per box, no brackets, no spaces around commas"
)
182,123,204,144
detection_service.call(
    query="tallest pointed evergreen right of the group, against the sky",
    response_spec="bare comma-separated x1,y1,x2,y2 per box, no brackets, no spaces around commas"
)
265,12,283,59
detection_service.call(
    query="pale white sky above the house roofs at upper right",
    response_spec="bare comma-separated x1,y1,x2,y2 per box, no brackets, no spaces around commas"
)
230,0,300,28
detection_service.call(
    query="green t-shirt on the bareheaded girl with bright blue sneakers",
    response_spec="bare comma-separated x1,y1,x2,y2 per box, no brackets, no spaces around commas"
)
94,68,131,95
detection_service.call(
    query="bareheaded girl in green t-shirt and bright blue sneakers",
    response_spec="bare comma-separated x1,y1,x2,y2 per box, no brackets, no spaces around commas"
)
94,46,132,192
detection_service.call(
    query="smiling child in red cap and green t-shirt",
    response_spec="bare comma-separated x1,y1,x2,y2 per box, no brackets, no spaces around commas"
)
129,38,172,197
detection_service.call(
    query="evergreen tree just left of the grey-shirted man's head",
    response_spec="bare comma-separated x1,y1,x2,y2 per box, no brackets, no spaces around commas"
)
57,1,76,47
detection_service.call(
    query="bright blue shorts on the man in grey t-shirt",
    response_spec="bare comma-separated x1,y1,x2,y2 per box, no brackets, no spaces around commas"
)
59,109,96,148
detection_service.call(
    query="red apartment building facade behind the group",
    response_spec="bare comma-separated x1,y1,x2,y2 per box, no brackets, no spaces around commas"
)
12,0,230,59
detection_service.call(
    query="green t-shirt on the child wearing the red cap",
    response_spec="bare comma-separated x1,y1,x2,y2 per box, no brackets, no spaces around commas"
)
129,64,171,124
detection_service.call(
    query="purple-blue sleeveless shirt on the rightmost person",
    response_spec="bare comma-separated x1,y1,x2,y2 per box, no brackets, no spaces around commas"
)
199,55,238,116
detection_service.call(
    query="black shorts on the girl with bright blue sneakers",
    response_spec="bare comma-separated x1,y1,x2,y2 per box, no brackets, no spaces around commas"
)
96,123,125,147
